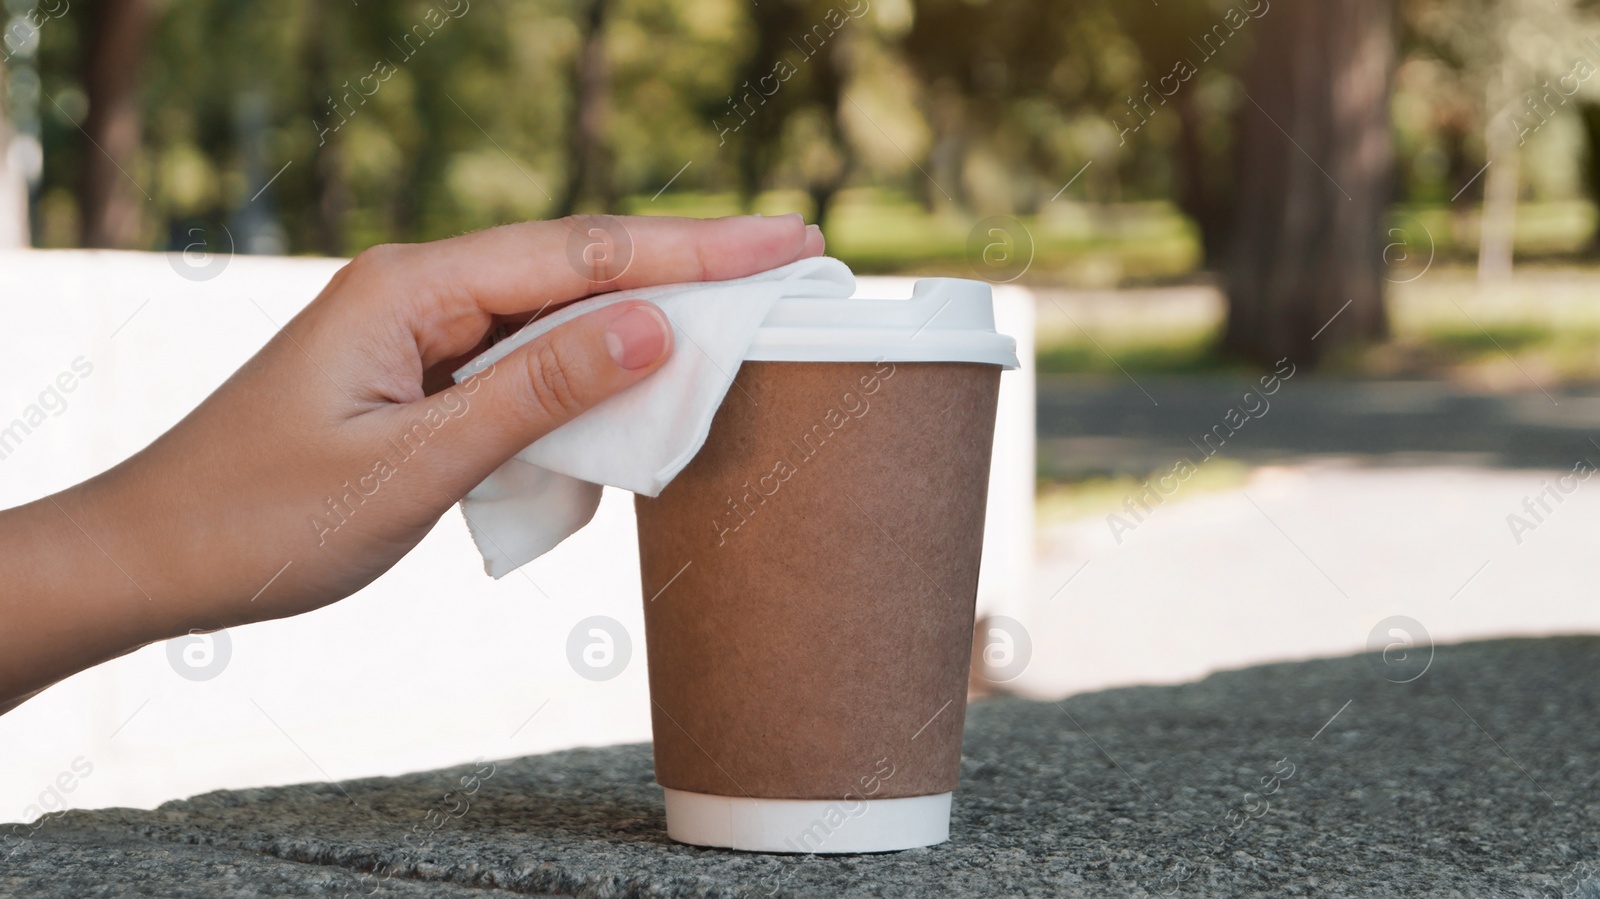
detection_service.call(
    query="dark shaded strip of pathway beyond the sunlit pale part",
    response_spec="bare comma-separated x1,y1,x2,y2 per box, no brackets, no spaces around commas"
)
1038,374,1600,478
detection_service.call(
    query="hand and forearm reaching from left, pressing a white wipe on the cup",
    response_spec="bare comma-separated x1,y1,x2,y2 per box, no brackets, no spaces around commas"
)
0,216,822,710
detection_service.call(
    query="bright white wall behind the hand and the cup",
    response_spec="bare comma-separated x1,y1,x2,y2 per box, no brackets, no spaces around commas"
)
0,251,1034,821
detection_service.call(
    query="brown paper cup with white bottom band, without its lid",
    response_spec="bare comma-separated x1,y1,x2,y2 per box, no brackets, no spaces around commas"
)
635,355,1000,853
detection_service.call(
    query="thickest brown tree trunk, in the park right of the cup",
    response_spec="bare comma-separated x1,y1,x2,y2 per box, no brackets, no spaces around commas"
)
1222,0,1395,366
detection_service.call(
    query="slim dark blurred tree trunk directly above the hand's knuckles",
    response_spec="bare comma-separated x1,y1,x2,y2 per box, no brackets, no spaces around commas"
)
555,0,616,216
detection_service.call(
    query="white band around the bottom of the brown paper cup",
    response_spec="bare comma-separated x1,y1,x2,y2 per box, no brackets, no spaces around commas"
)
662,787,950,854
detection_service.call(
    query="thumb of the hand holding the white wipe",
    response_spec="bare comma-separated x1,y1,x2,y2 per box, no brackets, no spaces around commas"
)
410,301,672,496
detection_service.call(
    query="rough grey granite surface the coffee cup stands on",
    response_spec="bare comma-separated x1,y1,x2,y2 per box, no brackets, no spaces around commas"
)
0,637,1600,897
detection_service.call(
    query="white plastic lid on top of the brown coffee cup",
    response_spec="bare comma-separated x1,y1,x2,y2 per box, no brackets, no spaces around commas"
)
744,278,1018,368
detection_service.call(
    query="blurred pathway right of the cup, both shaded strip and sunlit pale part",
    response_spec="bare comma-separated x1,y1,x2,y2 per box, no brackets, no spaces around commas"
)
1013,378,1600,694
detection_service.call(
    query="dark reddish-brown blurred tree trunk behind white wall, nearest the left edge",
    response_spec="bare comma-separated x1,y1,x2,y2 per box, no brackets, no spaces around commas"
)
78,0,150,250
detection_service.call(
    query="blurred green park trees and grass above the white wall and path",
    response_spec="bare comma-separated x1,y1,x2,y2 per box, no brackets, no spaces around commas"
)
9,0,1600,496
